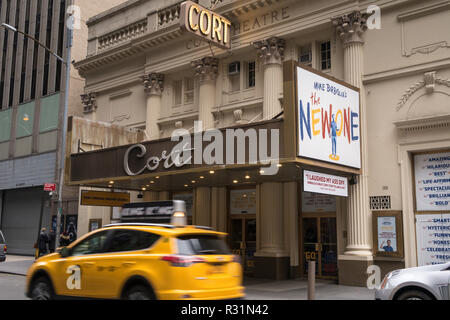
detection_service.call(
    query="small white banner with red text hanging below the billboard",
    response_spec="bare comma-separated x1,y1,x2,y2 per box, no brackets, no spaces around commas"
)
303,170,348,197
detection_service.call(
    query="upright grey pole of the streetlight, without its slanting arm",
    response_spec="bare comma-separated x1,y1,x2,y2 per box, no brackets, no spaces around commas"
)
55,17,73,248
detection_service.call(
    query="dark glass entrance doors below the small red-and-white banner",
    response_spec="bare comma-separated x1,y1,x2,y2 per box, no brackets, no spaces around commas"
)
303,217,338,278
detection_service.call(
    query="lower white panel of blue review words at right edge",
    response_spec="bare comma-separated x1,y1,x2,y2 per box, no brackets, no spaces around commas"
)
416,214,450,266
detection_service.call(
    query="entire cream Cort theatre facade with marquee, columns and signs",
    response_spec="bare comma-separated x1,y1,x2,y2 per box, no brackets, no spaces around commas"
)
66,0,450,286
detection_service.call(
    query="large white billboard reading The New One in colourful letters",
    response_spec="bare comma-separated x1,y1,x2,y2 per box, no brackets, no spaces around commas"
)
296,66,361,169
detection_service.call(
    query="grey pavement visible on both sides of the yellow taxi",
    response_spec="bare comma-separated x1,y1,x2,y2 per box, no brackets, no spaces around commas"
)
0,255,375,300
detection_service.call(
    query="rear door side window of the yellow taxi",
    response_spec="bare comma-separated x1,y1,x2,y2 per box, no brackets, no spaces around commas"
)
108,230,160,252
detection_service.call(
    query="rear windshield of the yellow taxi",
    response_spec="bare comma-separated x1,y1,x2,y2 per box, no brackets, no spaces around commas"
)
177,235,231,255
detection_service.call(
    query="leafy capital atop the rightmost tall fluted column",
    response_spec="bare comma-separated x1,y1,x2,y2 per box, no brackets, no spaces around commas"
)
331,11,370,45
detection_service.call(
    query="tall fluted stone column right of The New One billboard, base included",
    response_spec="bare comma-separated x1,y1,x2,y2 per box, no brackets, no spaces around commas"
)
333,11,373,285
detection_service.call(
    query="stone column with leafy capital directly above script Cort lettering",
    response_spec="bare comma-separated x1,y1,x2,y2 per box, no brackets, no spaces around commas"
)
142,73,164,140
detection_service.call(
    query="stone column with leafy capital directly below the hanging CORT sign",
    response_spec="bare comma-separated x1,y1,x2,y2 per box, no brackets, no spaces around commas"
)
191,57,219,131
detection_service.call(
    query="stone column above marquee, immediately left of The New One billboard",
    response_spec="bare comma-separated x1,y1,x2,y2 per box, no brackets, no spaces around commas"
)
253,37,286,120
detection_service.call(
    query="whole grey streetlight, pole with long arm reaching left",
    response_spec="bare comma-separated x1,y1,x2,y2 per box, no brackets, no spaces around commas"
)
0,15,74,248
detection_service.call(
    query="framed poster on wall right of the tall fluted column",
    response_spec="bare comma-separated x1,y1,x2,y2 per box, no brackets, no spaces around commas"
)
373,211,404,257
